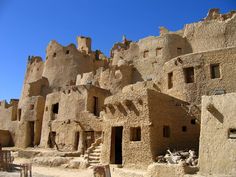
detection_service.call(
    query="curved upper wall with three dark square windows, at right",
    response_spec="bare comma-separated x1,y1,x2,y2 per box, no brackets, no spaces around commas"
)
161,48,236,105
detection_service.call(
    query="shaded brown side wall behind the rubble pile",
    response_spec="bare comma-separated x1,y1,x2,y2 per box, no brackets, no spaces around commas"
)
148,90,200,157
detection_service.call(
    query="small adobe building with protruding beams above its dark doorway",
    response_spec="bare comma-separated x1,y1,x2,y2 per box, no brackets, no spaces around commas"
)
101,82,200,169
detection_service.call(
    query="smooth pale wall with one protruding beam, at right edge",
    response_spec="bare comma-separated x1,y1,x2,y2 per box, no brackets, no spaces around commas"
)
199,93,236,176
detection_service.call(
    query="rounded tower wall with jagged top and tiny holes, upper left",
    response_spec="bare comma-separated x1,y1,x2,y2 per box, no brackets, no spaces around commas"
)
43,41,108,89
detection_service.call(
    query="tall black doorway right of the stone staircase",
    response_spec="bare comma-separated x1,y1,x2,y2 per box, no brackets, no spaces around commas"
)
110,127,123,164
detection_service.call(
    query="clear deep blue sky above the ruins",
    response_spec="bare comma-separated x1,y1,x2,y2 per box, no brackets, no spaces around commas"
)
0,0,236,100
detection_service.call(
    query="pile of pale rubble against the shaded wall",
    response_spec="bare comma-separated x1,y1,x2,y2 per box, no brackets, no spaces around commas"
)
156,149,198,166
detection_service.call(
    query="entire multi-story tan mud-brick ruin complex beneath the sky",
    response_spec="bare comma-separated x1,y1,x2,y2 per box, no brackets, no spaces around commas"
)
0,9,236,175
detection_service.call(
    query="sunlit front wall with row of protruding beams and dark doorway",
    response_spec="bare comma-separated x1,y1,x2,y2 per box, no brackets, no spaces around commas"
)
101,87,153,169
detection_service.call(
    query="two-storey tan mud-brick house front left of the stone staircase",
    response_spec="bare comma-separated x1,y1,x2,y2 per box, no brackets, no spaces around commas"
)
40,85,109,153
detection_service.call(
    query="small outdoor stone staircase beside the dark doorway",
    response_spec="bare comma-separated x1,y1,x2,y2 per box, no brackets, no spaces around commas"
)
86,138,102,166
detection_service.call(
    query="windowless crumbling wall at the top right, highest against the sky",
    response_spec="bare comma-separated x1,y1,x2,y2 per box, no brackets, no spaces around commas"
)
184,9,236,53
